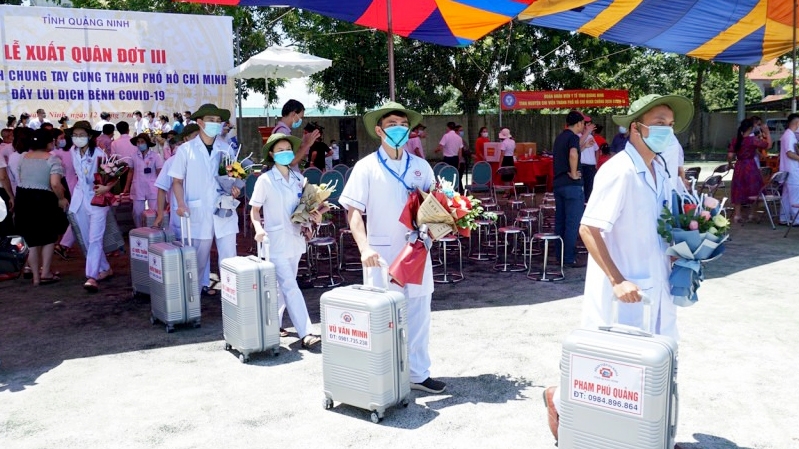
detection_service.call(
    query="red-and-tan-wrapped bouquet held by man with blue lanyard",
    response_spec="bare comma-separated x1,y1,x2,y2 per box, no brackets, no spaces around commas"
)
388,177,496,287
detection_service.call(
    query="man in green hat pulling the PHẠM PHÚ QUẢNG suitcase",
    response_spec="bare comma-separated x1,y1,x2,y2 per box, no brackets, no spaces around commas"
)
544,94,694,439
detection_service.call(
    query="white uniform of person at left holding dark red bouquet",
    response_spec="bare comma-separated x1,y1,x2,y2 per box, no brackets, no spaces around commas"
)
69,146,111,279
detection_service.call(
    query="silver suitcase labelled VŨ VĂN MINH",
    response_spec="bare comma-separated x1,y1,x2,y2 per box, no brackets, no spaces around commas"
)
320,266,410,423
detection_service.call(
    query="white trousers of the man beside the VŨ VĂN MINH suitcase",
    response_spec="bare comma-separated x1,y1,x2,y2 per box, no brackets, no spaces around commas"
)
408,294,433,383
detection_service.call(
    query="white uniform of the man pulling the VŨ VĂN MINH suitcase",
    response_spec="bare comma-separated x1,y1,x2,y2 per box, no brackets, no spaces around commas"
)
339,147,438,383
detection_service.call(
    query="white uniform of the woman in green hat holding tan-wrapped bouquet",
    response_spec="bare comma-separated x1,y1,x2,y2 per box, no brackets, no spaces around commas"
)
250,167,311,339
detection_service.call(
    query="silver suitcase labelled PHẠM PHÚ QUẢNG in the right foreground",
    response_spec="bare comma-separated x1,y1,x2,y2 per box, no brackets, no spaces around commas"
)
558,297,678,449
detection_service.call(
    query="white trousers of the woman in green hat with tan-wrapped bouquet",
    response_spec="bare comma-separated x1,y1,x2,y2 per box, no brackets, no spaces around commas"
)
270,256,311,338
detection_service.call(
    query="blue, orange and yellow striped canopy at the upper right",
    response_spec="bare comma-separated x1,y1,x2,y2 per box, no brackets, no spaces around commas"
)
518,0,795,65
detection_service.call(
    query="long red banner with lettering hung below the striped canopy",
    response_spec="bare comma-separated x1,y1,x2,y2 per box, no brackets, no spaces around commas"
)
501,89,630,111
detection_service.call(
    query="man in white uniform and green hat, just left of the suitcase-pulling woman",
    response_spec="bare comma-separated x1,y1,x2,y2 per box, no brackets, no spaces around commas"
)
169,104,241,296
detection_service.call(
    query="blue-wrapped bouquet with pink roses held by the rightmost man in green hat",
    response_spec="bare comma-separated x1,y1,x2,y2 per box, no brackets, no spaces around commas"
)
658,189,730,307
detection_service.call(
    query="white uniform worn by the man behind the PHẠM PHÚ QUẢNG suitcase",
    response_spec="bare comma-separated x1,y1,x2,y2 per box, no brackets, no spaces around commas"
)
580,143,679,340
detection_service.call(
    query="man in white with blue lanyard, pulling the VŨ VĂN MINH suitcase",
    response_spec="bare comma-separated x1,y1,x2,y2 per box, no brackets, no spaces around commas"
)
339,102,446,393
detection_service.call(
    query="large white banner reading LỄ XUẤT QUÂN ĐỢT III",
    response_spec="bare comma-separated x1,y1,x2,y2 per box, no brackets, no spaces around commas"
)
0,6,235,123
